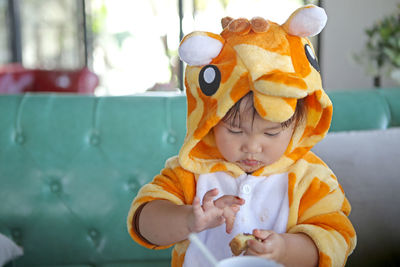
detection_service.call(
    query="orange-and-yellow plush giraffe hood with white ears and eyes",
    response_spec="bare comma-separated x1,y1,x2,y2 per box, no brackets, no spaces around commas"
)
179,5,332,176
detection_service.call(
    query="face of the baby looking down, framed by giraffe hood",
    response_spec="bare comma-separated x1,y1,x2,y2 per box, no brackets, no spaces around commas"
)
214,99,295,173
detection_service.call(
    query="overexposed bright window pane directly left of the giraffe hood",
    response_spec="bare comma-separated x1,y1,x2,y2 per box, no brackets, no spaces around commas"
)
88,0,179,95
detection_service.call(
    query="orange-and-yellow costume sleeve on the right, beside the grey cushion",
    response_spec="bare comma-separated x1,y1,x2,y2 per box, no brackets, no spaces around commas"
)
288,155,357,267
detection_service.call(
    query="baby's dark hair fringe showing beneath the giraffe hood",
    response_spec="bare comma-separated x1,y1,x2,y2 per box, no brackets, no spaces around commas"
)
222,91,306,128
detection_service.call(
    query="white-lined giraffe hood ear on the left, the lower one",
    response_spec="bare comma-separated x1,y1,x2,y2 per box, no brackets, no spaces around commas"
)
178,32,225,66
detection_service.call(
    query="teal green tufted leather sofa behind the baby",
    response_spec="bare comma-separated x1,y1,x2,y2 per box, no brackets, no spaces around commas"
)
0,89,400,267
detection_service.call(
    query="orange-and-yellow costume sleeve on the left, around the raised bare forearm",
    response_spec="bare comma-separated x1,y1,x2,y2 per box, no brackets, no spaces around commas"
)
127,157,196,249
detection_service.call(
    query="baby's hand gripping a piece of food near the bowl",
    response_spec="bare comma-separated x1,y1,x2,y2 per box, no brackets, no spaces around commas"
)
245,230,286,262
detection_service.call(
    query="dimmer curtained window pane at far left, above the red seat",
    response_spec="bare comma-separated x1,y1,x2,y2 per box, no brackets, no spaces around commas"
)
19,0,85,69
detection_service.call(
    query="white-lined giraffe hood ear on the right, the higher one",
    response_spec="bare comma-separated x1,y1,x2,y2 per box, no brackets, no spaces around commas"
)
282,5,328,37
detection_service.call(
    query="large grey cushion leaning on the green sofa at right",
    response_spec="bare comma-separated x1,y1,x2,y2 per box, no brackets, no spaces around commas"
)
313,128,400,266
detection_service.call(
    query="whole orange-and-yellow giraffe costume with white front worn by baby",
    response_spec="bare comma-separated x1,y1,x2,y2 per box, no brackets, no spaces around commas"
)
127,5,356,266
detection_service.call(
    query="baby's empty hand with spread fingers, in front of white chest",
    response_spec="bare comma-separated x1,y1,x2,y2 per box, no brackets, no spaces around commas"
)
188,188,244,233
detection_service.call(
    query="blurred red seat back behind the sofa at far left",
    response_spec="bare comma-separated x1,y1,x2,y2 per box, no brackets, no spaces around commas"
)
0,63,99,94
